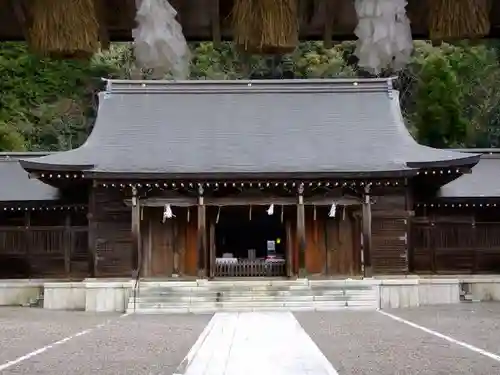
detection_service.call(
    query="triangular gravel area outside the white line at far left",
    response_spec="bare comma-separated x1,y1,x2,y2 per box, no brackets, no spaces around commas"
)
0,307,119,366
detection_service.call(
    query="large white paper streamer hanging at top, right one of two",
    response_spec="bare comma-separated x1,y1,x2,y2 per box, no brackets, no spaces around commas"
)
354,0,413,74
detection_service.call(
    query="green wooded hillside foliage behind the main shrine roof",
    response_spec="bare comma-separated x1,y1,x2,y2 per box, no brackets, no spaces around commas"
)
0,41,500,151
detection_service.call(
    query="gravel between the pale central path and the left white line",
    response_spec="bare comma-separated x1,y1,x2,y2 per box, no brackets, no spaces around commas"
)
0,313,211,375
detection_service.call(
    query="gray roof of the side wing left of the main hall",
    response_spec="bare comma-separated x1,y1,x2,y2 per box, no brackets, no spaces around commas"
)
0,153,58,203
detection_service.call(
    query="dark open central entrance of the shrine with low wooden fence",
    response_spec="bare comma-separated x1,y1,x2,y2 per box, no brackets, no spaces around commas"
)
211,206,290,277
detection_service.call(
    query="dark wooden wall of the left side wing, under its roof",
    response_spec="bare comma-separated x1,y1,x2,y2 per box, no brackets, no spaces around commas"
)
0,212,89,279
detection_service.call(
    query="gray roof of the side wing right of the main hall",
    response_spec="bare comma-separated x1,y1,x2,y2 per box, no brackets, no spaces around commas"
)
439,153,500,198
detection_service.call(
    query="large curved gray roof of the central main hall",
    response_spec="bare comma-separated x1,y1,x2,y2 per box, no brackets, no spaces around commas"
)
22,79,478,177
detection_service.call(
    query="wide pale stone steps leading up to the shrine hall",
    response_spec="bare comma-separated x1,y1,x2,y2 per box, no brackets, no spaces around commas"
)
127,279,379,314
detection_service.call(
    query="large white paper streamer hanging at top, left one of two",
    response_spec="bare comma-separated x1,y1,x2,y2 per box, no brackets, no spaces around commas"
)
132,0,191,79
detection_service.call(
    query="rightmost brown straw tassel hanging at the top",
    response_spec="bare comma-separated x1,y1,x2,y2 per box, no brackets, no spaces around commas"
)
428,0,492,41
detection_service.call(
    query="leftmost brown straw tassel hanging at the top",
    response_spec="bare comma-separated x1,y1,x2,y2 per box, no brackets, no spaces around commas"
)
28,0,99,58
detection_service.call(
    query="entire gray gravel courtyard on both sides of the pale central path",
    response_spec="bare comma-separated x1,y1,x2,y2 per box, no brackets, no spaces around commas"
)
0,303,500,375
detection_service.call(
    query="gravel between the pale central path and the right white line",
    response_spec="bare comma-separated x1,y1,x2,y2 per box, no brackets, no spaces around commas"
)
295,307,500,375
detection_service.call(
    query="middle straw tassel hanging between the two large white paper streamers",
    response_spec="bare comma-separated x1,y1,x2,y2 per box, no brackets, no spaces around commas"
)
232,0,299,54
